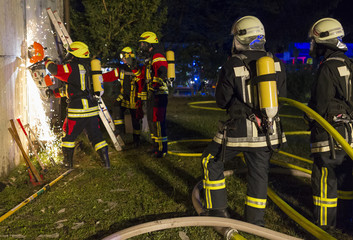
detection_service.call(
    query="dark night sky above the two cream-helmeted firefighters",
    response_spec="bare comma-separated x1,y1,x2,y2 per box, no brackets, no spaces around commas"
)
162,0,353,52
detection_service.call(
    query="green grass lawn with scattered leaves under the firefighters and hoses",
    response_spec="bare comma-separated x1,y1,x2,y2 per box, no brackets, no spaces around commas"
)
0,97,353,240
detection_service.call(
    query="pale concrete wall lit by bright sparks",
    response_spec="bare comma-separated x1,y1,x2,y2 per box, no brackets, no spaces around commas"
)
0,0,63,177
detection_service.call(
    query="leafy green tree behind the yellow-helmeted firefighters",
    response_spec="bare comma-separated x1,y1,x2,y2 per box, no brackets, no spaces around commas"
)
70,0,167,65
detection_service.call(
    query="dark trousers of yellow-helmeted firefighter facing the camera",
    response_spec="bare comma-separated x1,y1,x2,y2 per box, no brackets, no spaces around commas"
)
113,103,141,143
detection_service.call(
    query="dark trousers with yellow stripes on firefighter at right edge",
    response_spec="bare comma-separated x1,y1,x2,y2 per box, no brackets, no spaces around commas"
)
311,150,353,227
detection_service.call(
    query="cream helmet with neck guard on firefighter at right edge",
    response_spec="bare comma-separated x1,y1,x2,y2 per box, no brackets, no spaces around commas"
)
309,18,348,57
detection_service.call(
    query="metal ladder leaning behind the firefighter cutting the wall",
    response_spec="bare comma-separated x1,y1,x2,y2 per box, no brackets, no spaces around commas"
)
47,8,125,151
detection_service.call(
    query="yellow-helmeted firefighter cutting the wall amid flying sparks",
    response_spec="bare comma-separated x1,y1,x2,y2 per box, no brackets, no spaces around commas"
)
45,41,110,168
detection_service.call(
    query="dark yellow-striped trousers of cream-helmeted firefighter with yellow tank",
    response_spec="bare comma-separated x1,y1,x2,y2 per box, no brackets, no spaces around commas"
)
202,141,272,226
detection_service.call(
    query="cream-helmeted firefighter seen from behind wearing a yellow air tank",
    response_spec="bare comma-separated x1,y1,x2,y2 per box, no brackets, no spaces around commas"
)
202,16,286,226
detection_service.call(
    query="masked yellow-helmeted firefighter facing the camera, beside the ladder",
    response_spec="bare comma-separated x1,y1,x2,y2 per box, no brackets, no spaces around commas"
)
103,47,146,147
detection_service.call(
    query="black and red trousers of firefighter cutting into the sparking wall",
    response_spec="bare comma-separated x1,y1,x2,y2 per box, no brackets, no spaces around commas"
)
62,116,108,151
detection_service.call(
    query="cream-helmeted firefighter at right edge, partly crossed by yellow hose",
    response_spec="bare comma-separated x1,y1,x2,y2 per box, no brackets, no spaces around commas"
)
308,18,353,230
